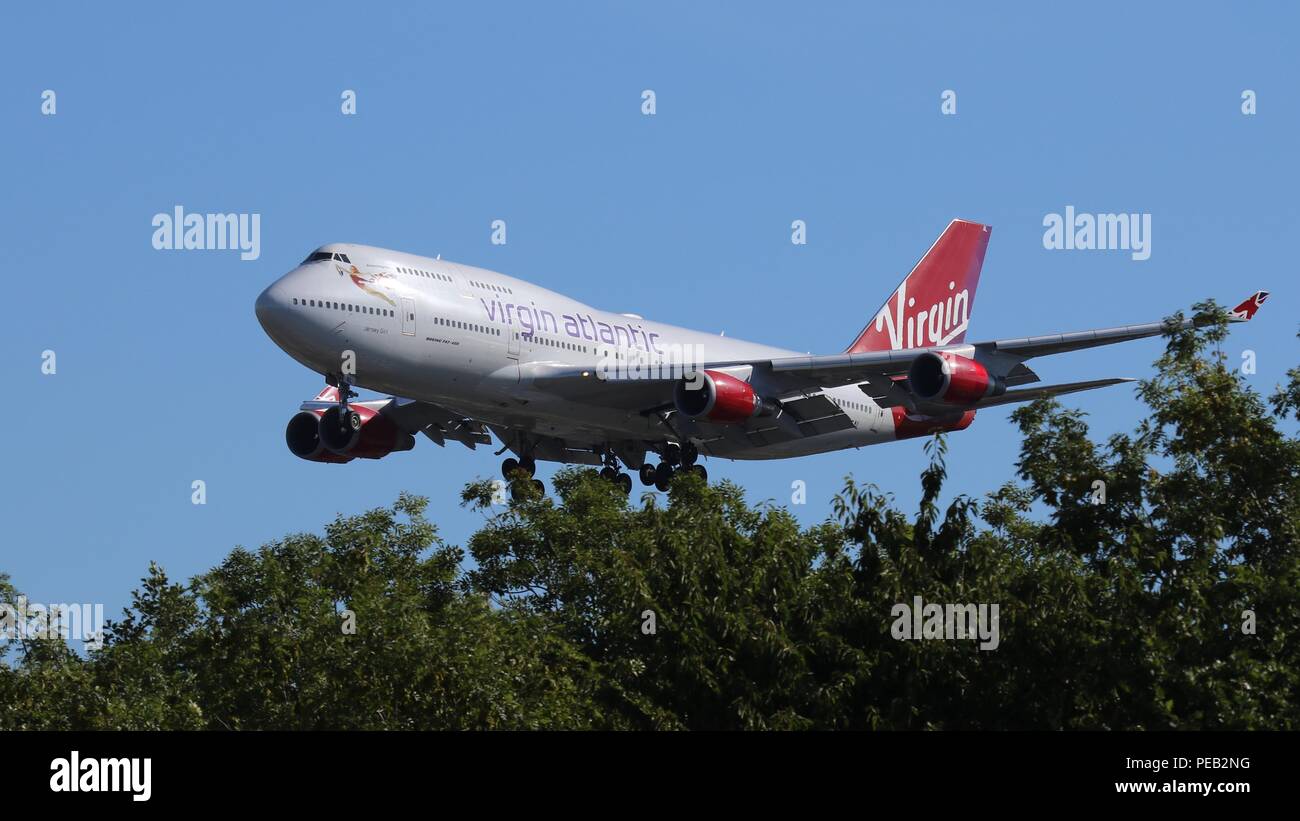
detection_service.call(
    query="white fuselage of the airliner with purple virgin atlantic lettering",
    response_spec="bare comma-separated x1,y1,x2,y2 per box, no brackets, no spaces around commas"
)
257,244,896,459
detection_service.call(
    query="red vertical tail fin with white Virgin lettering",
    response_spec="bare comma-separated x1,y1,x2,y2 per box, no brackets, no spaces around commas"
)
845,220,993,353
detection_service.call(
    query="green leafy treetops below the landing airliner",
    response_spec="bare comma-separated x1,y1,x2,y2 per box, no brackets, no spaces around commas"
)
0,304,1300,729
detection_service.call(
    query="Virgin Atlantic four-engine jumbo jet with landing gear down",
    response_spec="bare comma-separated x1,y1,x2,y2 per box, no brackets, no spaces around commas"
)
256,220,1268,494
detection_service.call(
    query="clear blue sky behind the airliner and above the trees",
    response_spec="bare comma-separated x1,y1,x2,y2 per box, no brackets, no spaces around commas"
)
0,3,1300,631
